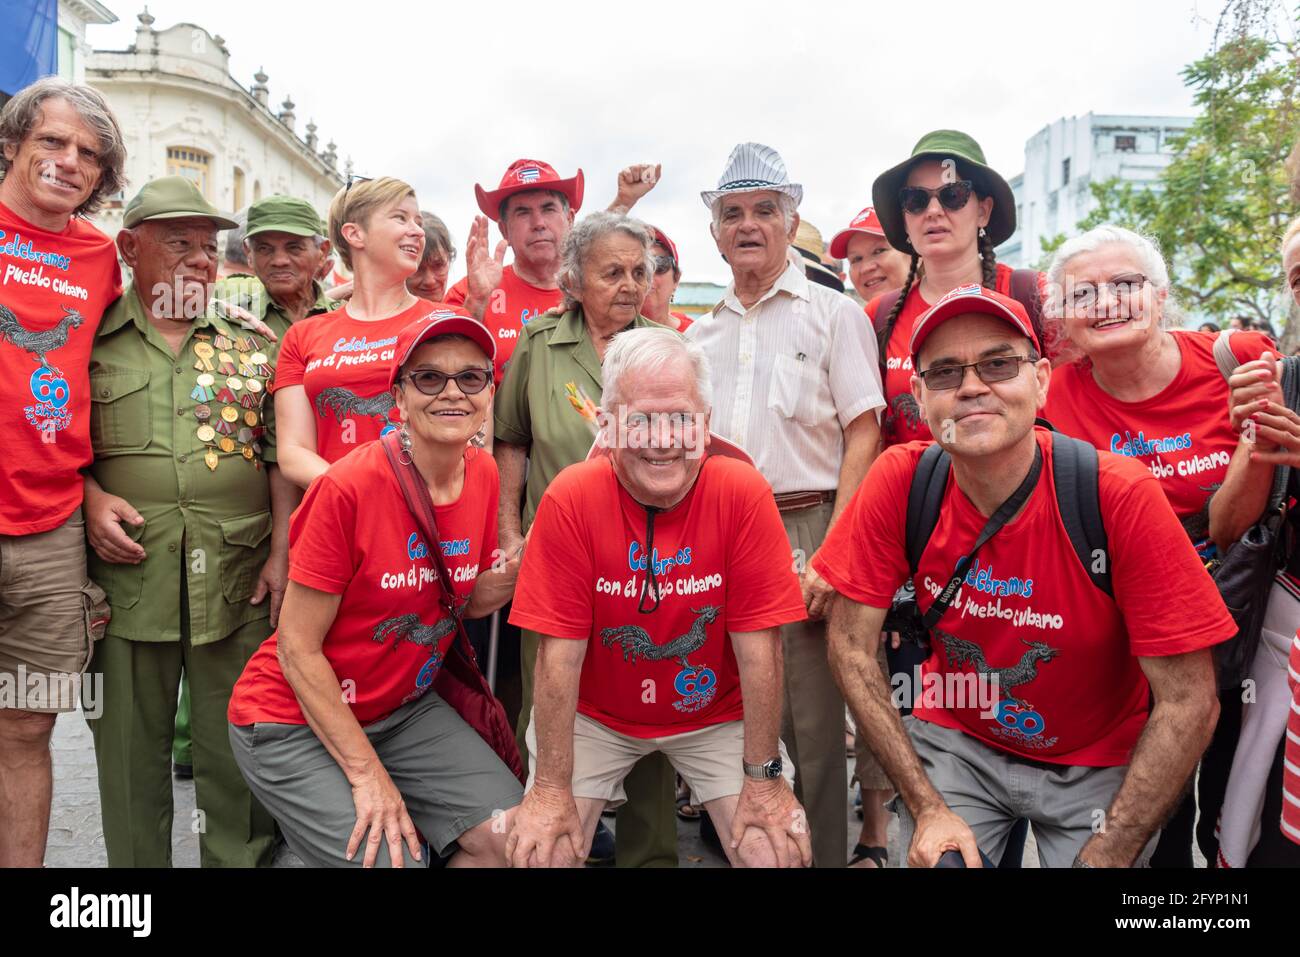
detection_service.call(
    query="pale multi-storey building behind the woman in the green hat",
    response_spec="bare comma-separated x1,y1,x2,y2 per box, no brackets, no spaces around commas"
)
997,113,1192,267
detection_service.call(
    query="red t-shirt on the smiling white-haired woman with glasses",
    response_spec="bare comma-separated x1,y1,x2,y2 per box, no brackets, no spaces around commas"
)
1043,329,1277,549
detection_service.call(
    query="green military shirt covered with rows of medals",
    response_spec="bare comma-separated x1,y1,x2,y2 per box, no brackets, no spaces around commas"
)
87,287,273,645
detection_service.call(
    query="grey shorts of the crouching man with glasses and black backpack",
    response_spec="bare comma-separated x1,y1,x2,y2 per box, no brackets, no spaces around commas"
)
892,715,1160,867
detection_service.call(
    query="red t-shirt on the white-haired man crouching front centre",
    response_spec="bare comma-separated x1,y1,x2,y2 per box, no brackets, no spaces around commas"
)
510,455,805,737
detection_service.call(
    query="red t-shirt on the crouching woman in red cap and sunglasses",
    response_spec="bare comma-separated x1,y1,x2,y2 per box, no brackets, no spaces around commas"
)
228,442,498,726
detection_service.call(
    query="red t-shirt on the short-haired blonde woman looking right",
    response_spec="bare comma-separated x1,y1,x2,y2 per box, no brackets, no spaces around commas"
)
270,299,438,463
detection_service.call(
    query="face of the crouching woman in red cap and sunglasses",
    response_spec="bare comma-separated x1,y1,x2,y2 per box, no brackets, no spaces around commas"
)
394,338,493,446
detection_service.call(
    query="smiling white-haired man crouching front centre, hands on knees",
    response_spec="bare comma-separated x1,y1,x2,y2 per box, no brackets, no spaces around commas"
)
507,329,813,867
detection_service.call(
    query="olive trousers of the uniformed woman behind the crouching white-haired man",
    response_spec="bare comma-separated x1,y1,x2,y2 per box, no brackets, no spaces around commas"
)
516,629,677,867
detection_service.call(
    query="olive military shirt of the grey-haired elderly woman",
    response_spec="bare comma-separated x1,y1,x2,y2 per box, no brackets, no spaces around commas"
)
493,307,662,531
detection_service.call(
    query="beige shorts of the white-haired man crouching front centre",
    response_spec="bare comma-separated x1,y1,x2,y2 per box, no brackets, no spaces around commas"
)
524,714,794,807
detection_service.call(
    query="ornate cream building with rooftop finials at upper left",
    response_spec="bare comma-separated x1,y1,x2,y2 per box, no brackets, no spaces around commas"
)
86,12,343,235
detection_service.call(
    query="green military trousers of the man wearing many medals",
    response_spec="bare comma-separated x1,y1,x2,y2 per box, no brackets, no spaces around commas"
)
87,605,276,867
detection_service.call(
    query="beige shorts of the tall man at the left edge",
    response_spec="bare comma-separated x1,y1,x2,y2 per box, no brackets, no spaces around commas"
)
0,508,109,713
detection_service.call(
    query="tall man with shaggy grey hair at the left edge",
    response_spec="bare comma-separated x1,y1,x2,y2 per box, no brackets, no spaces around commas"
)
0,78,126,867
